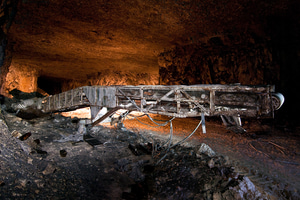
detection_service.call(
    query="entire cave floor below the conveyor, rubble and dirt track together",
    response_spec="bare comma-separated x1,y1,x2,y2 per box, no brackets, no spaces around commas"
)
0,108,300,199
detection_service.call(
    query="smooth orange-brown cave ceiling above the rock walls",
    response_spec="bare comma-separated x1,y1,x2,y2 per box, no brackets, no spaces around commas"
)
8,0,288,79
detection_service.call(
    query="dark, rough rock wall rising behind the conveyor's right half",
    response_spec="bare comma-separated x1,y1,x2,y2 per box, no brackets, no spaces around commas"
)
158,37,280,85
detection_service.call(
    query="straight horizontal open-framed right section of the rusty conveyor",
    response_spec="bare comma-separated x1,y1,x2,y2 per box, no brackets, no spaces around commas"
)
116,85,274,118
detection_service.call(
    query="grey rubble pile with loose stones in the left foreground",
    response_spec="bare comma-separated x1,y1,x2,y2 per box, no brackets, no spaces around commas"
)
0,108,276,199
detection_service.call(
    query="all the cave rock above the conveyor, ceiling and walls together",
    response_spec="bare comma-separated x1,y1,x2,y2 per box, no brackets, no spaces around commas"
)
0,0,300,111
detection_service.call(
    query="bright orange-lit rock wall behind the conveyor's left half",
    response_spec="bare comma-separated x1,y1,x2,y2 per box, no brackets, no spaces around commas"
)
1,65,159,97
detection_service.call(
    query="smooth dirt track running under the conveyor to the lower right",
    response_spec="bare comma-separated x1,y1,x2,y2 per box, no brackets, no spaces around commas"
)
125,113,300,199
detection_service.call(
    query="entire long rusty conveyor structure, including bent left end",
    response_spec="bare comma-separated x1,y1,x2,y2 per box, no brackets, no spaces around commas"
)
41,84,284,130
